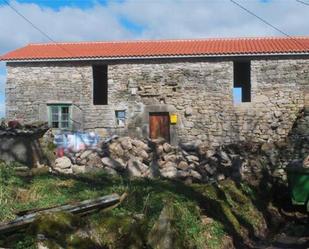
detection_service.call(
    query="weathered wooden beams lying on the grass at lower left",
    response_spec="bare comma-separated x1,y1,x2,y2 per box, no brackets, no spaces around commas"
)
0,194,122,234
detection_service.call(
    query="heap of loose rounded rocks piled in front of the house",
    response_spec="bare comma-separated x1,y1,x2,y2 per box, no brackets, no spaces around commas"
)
52,137,243,182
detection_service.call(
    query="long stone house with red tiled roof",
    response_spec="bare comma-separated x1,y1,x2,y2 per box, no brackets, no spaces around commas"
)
0,37,309,146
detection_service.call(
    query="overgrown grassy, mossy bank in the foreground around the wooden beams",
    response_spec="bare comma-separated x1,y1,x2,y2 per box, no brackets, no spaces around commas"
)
0,163,266,249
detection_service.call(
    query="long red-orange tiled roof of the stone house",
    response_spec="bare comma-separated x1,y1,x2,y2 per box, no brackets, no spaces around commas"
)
0,36,309,61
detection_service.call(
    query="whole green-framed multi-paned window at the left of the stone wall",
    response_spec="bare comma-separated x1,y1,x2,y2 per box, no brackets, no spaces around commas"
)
48,104,72,129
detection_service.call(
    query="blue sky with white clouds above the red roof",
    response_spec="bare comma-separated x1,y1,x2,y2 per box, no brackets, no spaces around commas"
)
0,0,309,117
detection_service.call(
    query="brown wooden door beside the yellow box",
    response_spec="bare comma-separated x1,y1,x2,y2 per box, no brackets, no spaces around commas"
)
149,112,170,142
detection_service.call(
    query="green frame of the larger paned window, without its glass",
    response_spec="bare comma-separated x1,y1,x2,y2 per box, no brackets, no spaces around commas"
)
47,104,72,130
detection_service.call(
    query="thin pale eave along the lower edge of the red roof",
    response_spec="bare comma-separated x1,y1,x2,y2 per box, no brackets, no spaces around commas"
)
0,52,309,63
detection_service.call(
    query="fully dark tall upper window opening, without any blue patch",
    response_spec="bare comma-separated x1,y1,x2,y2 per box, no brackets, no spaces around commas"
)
92,65,108,105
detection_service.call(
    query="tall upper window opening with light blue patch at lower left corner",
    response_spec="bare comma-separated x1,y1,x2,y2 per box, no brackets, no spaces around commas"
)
233,61,251,104
